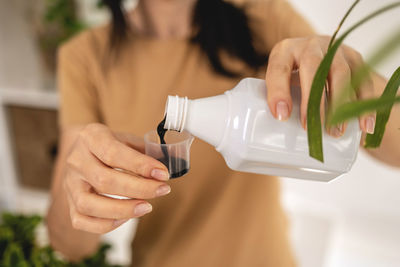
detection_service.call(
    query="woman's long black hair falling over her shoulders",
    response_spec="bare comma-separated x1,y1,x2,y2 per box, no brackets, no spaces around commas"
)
103,0,268,77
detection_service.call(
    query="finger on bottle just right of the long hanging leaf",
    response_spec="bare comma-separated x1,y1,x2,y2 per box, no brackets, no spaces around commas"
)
327,51,354,137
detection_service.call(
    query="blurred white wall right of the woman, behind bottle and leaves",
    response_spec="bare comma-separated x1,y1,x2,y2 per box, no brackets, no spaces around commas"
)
282,0,400,267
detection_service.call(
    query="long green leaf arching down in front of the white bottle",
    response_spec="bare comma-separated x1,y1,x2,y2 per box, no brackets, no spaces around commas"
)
307,2,400,162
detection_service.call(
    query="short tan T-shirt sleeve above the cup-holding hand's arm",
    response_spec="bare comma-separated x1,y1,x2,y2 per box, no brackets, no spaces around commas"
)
57,32,100,128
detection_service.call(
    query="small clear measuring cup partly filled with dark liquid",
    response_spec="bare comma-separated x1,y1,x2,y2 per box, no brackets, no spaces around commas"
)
144,131,194,179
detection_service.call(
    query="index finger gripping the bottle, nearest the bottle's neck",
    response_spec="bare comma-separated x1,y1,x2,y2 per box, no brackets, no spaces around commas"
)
265,41,294,121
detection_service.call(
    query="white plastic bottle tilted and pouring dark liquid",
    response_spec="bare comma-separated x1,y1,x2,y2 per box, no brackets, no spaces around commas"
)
165,78,361,181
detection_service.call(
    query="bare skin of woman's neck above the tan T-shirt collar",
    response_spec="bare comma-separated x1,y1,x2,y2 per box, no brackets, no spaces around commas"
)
130,0,196,39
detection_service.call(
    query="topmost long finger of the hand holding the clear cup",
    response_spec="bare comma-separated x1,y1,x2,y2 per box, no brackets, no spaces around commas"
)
83,124,169,181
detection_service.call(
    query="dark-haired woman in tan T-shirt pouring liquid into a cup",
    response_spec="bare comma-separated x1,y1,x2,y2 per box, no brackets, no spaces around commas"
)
48,0,400,267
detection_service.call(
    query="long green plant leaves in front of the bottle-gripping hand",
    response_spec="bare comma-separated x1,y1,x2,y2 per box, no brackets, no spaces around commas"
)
307,0,400,162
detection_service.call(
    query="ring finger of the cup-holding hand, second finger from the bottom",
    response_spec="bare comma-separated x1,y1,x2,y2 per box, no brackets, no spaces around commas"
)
67,174,152,220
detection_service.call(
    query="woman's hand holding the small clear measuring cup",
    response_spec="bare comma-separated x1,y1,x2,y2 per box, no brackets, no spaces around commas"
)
64,124,171,234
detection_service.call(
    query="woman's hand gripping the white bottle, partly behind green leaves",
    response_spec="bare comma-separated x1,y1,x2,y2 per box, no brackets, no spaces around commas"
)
266,36,375,137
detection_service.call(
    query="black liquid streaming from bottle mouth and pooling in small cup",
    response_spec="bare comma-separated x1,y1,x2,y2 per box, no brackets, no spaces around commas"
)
157,117,189,178
